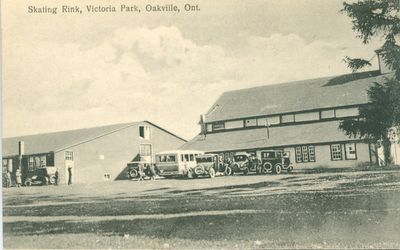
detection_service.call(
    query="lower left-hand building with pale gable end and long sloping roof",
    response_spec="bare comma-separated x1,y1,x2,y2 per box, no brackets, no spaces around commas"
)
2,121,186,184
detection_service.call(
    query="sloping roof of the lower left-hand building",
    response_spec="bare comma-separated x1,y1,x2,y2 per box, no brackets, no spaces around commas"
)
2,121,186,156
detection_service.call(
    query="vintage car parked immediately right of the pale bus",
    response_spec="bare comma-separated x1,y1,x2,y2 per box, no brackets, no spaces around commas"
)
192,154,221,178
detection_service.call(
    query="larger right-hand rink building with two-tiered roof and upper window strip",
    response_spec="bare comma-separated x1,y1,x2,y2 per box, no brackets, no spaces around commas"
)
181,70,391,168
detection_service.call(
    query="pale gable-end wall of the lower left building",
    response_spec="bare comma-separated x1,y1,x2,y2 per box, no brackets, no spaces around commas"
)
55,122,184,184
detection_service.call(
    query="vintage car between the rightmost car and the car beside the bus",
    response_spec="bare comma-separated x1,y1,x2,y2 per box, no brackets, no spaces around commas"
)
225,153,261,175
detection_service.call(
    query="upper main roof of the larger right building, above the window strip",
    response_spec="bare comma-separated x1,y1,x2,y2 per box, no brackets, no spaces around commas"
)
205,71,392,122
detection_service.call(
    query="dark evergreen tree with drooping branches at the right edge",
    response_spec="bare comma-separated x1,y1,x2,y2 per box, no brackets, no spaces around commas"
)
339,0,400,163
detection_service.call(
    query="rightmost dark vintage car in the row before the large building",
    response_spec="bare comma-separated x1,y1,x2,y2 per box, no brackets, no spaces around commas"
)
260,150,293,174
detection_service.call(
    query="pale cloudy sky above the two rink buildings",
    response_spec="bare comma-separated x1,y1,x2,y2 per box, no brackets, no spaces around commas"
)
1,0,382,139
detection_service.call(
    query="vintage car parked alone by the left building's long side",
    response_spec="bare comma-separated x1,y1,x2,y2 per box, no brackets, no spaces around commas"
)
24,167,57,186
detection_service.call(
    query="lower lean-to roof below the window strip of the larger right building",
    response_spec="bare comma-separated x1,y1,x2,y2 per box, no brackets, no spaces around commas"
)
180,121,360,152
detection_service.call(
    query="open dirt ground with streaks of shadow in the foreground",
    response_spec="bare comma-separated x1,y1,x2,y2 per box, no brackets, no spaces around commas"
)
3,171,400,249
